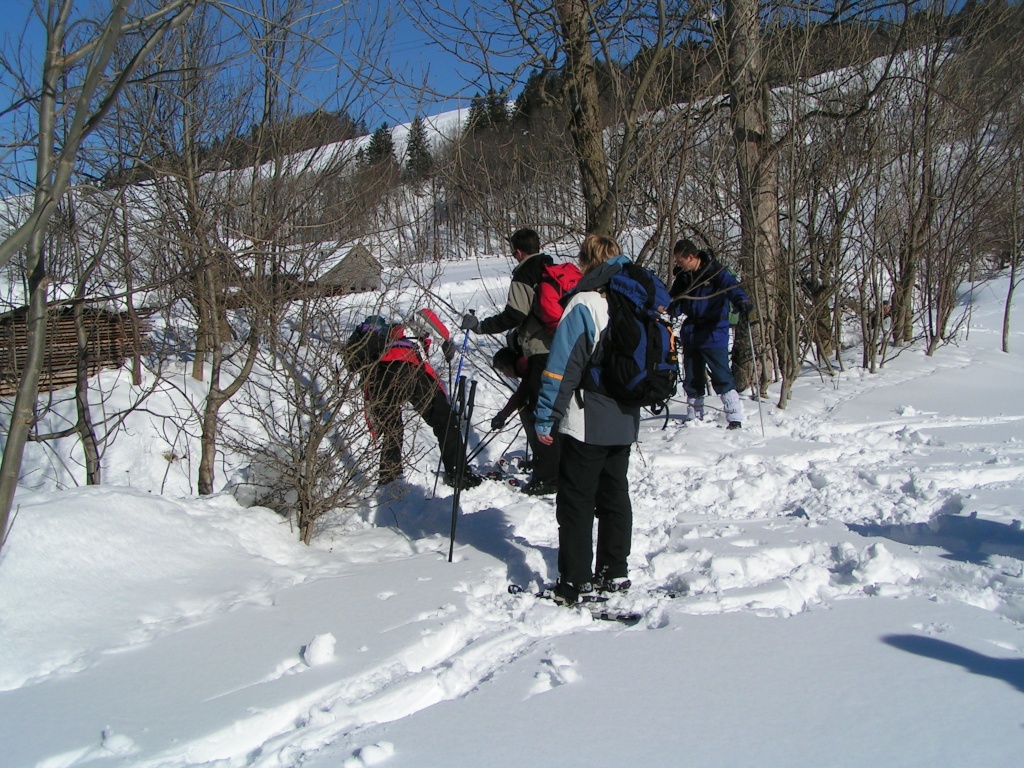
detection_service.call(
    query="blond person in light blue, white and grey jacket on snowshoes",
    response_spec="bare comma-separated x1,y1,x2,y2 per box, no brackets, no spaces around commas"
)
535,234,640,605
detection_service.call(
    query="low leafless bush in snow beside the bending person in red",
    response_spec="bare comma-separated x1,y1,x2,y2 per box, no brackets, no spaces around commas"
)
224,280,411,544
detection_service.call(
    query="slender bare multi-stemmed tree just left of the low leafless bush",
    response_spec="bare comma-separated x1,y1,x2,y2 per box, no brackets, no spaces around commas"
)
107,0,391,494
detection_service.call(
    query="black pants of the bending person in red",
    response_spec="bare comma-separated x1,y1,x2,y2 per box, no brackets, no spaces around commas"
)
366,360,464,484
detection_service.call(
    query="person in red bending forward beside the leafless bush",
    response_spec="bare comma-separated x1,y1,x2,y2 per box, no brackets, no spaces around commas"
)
345,310,481,488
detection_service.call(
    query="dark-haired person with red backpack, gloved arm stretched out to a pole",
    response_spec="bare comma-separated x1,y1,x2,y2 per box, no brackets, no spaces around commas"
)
461,228,561,496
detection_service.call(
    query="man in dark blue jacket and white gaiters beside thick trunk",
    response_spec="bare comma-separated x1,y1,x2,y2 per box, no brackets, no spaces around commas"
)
669,240,753,429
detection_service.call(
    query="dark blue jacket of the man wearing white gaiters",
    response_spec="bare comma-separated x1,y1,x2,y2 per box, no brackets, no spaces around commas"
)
669,257,751,349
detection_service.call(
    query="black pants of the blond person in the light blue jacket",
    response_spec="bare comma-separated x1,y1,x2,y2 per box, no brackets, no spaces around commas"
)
555,435,633,587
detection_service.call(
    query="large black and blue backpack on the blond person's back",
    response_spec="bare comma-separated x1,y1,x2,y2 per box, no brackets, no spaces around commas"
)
584,263,679,412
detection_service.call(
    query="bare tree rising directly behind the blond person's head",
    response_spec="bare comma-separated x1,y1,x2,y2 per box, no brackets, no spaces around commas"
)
405,0,712,239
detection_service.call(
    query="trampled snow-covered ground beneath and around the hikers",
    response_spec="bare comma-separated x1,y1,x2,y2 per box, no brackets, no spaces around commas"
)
0,260,1024,768
